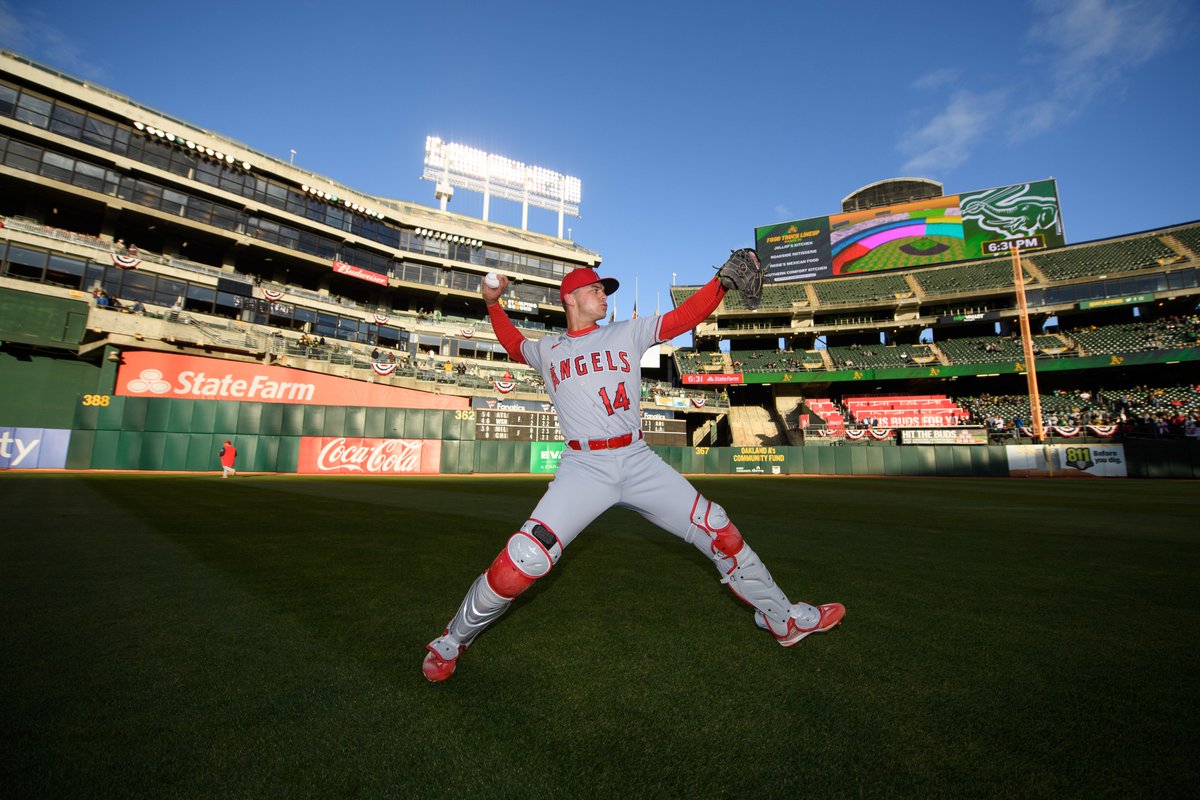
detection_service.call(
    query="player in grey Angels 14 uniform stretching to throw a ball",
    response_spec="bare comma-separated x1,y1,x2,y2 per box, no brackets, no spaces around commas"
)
421,249,846,681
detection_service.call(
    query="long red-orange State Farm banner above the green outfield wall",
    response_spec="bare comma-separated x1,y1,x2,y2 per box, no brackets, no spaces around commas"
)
116,350,468,409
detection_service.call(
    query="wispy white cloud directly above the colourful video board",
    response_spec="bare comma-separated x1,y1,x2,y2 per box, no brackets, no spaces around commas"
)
899,91,1003,175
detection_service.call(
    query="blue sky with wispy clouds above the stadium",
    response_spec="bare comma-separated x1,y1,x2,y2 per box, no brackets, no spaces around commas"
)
0,0,1200,317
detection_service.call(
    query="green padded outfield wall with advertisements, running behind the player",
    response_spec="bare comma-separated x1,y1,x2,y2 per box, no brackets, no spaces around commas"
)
0,354,1200,479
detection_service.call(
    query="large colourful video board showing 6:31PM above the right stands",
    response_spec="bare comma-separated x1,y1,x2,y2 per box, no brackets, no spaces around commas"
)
755,179,1066,283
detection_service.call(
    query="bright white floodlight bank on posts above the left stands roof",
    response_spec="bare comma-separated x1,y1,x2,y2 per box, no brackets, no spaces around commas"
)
421,136,583,239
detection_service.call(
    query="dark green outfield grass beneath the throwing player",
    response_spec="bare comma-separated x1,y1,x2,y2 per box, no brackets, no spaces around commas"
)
0,474,1200,800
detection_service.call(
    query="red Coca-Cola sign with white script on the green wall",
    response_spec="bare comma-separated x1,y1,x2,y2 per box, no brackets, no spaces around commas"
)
296,437,442,475
